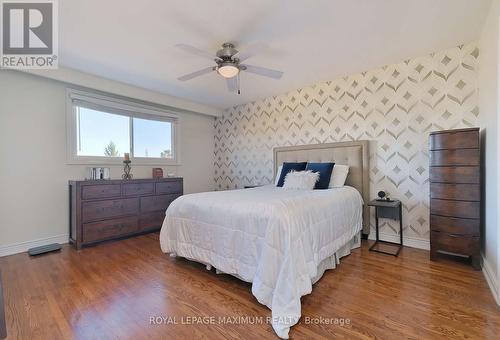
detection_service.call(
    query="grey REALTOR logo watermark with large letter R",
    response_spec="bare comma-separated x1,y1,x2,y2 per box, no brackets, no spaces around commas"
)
0,0,59,69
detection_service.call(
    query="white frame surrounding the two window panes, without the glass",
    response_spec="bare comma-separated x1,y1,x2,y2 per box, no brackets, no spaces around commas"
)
66,88,180,166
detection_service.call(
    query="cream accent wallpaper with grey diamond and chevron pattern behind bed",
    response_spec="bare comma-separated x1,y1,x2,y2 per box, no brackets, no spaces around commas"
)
215,43,479,242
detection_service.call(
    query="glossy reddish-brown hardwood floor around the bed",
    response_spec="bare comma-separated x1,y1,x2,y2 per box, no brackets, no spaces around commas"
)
0,234,500,339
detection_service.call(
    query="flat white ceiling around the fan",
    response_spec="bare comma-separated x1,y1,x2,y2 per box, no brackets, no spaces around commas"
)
59,0,490,108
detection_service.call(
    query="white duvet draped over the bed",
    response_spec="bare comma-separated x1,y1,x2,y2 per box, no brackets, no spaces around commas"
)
160,186,363,339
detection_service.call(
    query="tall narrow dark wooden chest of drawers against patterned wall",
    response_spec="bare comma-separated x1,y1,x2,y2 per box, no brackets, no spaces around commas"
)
429,128,482,270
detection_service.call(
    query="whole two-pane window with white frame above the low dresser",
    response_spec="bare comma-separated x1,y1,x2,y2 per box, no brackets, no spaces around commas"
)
68,90,178,165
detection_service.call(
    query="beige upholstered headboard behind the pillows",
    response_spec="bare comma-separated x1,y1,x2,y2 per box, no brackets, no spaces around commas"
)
274,140,370,234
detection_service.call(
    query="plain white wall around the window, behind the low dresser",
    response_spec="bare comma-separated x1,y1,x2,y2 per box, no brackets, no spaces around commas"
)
0,70,214,247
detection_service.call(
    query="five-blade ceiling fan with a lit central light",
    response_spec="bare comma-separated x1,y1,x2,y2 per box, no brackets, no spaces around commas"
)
175,43,283,94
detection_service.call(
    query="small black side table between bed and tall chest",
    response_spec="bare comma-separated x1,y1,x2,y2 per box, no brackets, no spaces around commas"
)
368,200,403,256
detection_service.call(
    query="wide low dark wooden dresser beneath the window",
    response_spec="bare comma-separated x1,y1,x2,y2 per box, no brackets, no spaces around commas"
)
69,178,183,249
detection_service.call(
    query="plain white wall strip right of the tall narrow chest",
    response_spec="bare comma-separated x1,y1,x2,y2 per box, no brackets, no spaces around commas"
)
478,0,500,300
